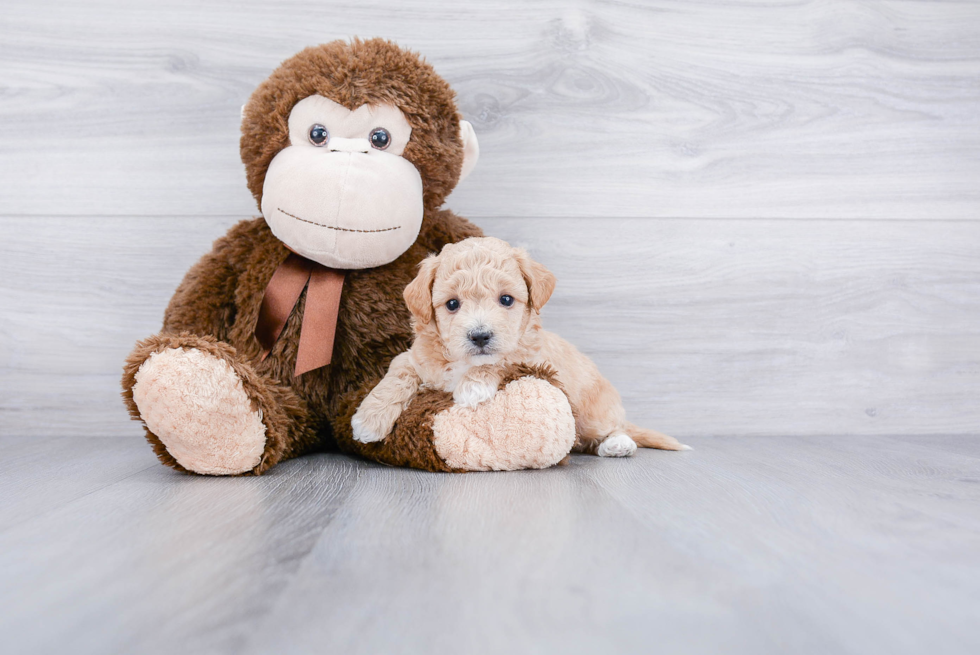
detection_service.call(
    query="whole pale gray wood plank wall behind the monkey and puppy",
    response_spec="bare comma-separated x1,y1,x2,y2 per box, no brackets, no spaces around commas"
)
0,0,980,436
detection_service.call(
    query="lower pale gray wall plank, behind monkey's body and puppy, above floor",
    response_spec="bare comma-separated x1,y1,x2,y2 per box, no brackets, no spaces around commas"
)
0,217,980,438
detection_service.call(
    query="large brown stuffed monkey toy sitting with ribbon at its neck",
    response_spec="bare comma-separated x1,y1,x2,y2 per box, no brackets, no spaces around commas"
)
122,39,574,475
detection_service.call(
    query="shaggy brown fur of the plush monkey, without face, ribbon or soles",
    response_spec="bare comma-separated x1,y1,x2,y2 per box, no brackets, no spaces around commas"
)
122,39,482,474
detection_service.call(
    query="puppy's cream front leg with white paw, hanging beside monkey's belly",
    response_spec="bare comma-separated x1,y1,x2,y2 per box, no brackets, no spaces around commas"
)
351,351,421,443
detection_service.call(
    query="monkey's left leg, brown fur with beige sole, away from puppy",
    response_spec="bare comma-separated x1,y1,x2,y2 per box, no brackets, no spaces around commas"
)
122,333,317,475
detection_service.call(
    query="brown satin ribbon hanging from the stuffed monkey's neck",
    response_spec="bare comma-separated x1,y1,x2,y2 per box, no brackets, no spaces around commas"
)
255,252,344,376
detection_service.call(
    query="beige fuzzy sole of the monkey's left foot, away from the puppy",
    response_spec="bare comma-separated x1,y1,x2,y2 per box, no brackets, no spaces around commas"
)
133,348,266,475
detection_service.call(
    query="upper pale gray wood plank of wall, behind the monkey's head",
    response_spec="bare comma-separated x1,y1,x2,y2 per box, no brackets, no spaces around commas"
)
0,0,980,220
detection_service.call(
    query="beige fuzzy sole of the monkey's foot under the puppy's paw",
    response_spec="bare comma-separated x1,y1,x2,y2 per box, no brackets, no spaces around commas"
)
432,377,575,471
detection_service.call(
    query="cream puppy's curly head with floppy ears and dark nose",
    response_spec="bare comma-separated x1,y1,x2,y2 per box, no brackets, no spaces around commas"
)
405,237,555,364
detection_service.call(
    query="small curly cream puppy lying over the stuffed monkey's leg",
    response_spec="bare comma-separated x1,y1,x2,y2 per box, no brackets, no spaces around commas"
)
351,237,688,457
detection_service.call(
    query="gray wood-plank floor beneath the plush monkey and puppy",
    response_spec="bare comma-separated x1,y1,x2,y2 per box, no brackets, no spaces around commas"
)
0,436,980,655
